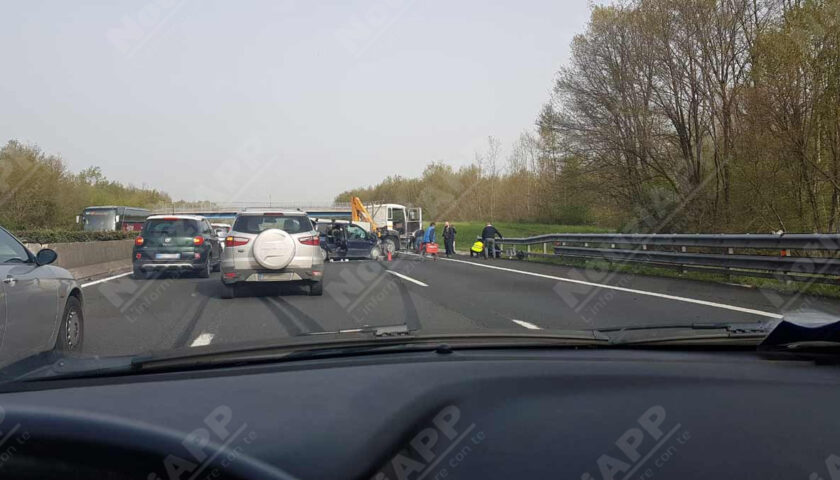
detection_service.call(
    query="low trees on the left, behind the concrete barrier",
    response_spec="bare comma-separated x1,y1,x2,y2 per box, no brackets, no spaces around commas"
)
0,140,171,230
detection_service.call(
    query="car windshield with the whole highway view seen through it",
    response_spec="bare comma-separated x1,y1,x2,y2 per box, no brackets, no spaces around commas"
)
0,0,840,382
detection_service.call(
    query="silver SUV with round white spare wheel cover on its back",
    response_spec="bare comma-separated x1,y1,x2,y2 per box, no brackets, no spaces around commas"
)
222,210,324,298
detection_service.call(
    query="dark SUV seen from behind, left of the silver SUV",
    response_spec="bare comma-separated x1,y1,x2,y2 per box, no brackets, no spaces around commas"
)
133,215,222,278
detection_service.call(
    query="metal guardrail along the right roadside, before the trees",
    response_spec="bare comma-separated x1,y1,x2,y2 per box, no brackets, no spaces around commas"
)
497,233,840,284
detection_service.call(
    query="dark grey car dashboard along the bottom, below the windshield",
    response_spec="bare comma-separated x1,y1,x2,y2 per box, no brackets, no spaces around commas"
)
0,348,840,480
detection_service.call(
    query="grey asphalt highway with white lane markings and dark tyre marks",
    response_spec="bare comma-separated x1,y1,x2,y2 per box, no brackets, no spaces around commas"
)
79,255,840,355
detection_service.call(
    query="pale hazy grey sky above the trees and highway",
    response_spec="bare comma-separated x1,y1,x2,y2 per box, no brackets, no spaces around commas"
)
0,0,589,202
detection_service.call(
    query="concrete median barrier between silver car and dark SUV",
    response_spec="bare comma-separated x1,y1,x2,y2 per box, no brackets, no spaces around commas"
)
26,239,134,280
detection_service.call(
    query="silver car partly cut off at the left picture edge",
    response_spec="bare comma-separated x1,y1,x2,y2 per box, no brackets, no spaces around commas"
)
0,227,84,364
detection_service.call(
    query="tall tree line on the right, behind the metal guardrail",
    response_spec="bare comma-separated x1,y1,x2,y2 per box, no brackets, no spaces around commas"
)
336,0,840,232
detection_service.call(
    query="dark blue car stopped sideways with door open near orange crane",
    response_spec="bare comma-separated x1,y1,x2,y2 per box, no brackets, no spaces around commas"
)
316,220,382,261
